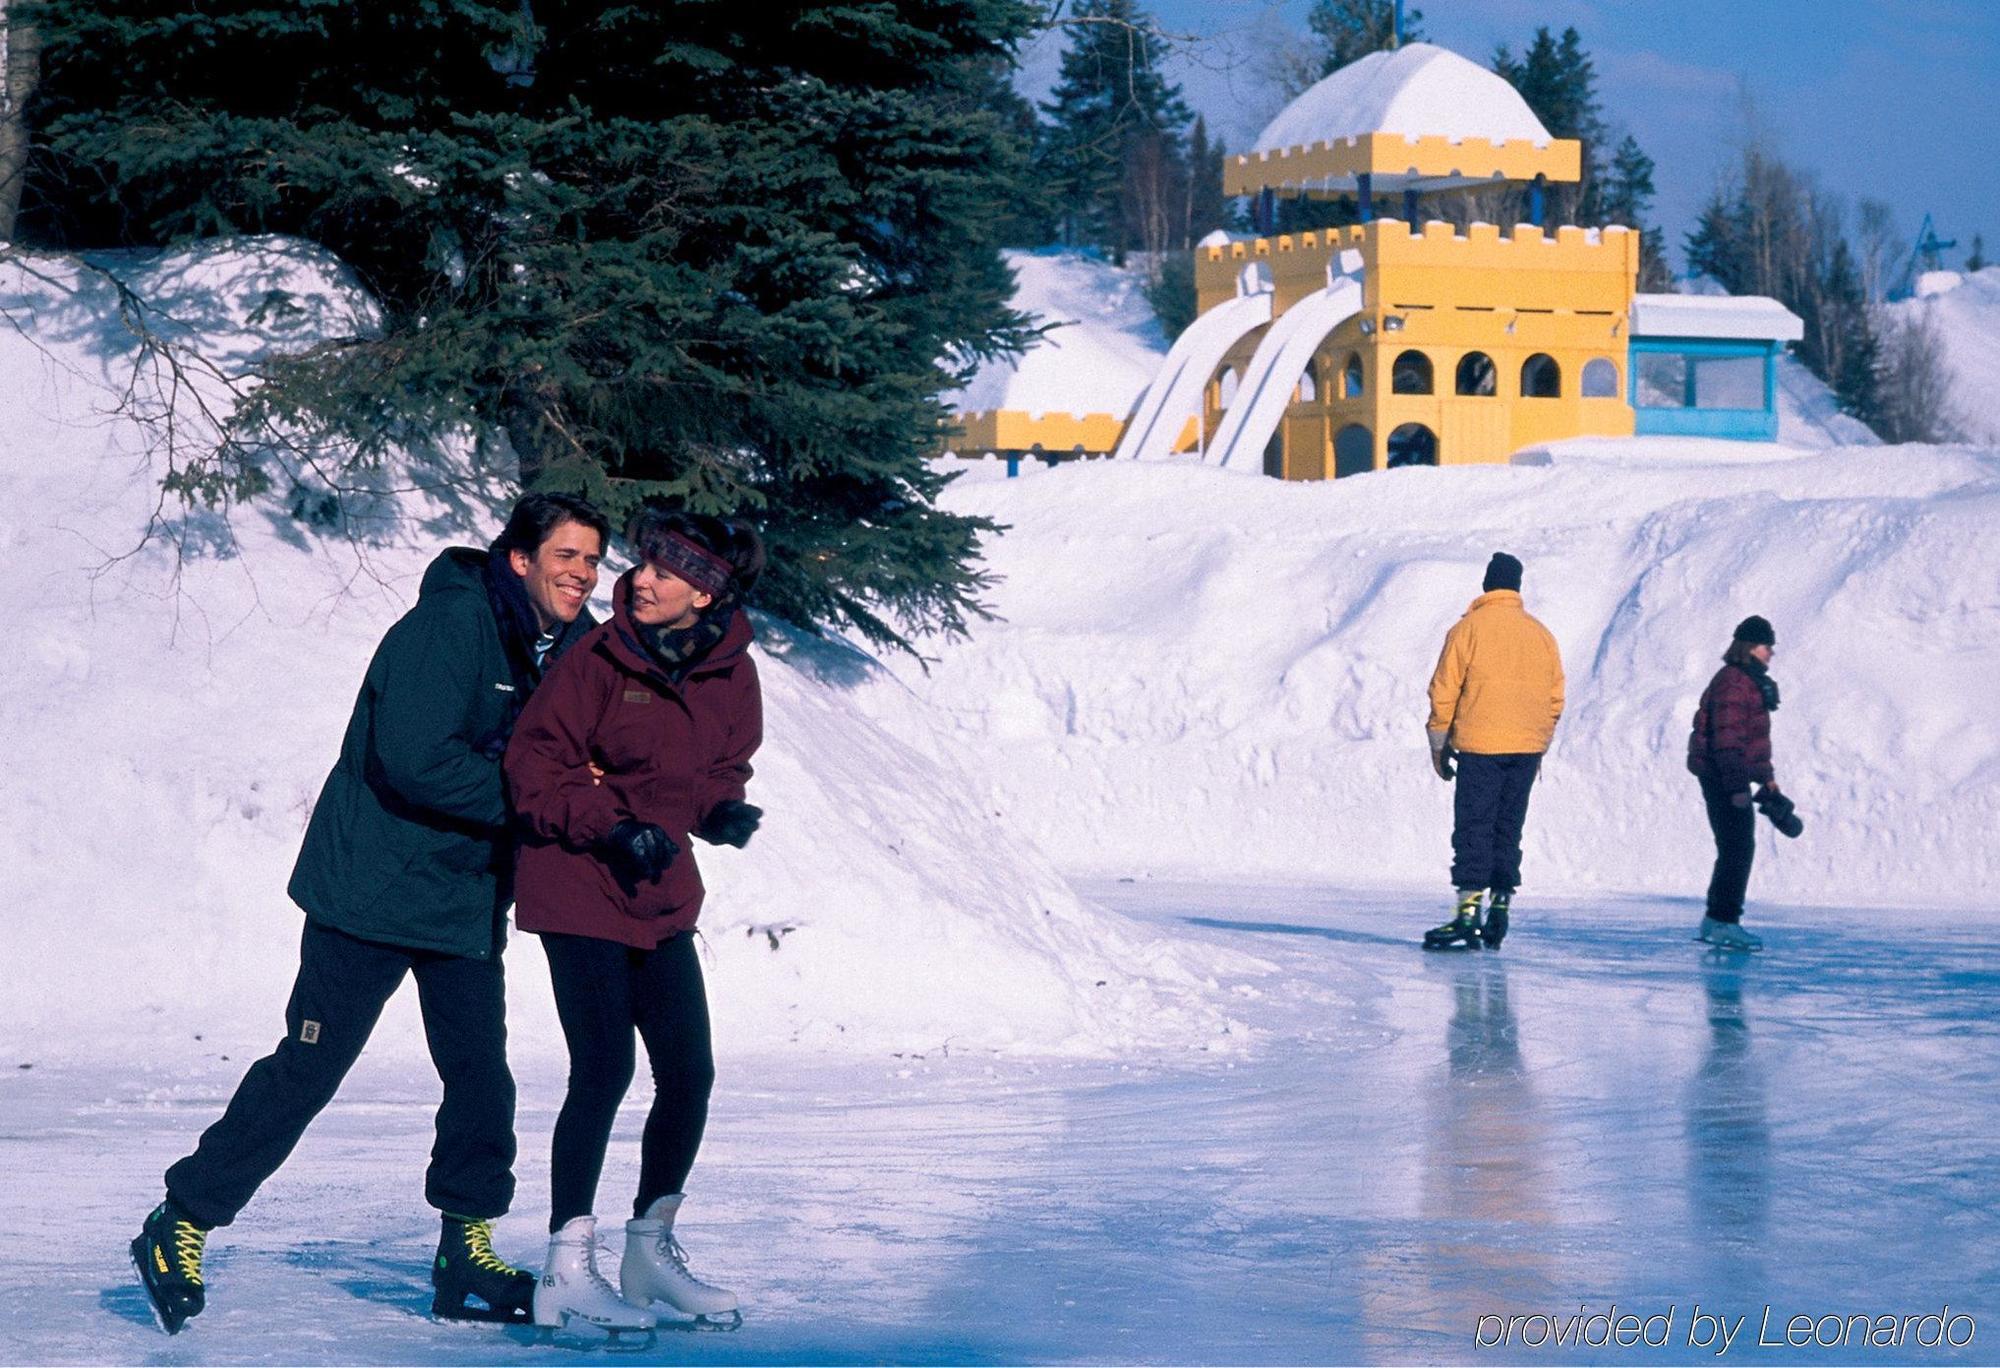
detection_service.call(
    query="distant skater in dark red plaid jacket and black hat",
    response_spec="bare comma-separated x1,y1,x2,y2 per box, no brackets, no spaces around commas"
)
1688,616,1778,950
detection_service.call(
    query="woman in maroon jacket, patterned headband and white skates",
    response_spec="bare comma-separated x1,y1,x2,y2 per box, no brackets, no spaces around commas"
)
506,510,764,1332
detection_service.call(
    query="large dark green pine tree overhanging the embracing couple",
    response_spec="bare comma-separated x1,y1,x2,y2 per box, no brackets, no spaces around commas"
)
14,0,1038,642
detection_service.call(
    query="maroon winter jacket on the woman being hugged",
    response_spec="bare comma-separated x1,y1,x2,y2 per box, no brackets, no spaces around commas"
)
506,574,764,950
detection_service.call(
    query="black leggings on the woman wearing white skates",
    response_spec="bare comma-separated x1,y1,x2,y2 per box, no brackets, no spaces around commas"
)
542,932,716,1232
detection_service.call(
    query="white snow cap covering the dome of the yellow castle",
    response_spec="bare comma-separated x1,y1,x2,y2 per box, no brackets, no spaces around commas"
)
1250,42,1550,152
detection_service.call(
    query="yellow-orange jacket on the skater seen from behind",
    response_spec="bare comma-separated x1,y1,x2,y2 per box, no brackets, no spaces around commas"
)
1428,590,1562,756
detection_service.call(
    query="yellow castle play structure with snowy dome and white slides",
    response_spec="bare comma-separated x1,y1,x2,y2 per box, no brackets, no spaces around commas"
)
946,44,1802,480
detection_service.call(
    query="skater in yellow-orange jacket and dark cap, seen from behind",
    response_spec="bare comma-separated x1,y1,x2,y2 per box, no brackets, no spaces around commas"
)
1424,552,1562,950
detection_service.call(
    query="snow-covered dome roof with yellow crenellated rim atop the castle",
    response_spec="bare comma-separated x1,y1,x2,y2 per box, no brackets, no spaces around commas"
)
1222,42,1580,196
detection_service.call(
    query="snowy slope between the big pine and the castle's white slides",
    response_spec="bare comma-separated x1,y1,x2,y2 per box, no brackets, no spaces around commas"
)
944,250,1172,418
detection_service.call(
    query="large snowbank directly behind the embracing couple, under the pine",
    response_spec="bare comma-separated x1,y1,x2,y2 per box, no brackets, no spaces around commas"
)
0,242,1256,1054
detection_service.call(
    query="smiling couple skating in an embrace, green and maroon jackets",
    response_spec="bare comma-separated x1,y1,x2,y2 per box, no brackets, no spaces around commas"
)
132,494,764,1332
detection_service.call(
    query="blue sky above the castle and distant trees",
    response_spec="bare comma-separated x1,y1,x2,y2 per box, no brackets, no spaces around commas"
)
1022,0,2000,276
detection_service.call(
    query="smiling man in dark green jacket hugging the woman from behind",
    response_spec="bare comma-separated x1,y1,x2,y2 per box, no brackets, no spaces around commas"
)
132,494,608,1334
